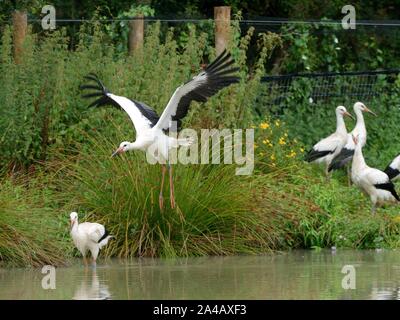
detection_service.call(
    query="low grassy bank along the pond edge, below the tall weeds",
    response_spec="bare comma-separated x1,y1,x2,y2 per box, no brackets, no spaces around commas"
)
0,141,400,266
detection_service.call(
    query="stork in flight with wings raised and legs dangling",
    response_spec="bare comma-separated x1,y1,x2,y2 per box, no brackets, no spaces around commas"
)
80,50,240,209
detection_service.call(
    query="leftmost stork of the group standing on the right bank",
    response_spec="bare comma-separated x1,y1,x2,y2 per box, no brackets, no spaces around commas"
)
305,106,353,178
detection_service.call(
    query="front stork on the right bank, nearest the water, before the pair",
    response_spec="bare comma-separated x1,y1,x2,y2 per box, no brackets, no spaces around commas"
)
351,137,400,213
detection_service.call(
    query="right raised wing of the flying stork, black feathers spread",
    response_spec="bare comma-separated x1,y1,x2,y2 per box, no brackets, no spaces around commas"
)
155,50,240,131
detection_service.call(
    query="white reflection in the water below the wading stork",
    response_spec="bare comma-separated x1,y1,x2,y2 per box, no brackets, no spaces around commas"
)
72,269,111,300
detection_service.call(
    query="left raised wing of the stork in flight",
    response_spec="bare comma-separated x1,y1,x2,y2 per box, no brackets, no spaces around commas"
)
79,73,159,135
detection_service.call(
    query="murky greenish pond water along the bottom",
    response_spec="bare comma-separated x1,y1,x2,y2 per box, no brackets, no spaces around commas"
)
0,250,400,299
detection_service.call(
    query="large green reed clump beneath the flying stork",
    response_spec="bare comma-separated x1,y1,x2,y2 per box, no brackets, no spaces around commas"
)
54,127,282,257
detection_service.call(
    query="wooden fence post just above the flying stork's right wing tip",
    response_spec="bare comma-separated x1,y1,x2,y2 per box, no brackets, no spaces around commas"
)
214,6,231,55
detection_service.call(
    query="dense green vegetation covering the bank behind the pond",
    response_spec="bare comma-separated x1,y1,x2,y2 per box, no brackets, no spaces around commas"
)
0,6,400,266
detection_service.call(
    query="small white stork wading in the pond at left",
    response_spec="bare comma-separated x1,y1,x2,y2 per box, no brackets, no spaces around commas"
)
70,212,113,266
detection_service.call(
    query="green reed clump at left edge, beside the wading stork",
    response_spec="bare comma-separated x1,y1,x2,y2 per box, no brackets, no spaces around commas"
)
0,177,68,267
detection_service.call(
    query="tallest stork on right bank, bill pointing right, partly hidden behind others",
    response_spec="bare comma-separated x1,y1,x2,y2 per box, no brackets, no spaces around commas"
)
328,102,376,179
